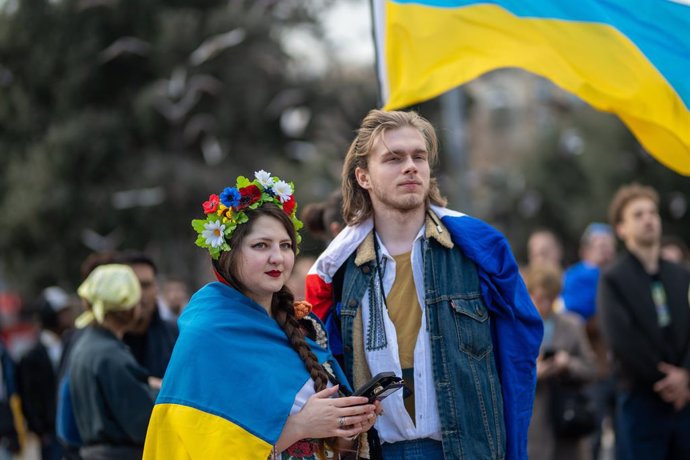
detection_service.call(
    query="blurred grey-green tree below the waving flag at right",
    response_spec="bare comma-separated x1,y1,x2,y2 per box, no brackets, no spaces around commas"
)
499,98,690,264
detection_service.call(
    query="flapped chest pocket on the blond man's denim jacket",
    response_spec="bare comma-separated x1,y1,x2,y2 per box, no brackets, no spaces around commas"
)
450,297,493,359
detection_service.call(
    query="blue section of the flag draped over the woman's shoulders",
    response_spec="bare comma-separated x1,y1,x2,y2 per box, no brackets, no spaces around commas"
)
156,283,346,444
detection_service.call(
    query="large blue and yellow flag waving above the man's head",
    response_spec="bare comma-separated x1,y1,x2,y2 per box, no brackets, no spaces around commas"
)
372,0,690,175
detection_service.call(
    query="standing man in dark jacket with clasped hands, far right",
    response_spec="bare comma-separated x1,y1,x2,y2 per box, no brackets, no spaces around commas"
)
598,184,690,460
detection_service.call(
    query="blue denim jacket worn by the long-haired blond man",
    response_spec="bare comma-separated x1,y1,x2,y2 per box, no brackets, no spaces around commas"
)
339,222,506,460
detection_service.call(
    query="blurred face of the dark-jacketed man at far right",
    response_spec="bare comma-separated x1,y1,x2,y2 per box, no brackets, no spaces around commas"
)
616,197,661,249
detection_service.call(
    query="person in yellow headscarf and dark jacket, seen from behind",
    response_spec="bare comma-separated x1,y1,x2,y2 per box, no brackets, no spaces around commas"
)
67,264,159,460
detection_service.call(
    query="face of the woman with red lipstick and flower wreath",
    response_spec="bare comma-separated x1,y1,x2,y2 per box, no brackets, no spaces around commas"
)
234,216,295,313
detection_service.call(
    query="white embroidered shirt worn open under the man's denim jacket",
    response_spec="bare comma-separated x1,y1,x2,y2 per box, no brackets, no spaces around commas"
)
360,232,441,443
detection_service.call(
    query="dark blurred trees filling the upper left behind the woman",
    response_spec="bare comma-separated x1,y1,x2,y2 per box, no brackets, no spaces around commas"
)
0,0,374,294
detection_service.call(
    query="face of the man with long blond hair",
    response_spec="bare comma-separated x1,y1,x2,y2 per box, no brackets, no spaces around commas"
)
355,127,431,213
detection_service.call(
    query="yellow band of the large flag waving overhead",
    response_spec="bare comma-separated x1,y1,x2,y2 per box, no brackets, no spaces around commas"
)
378,1,690,175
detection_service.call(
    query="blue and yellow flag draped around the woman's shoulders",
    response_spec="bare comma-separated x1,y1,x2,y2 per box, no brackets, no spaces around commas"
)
144,283,346,460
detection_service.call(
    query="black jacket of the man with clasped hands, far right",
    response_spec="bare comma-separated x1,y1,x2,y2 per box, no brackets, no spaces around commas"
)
597,251,690,391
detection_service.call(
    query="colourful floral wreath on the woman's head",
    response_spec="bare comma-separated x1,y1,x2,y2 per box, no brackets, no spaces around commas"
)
192,169,302,260
